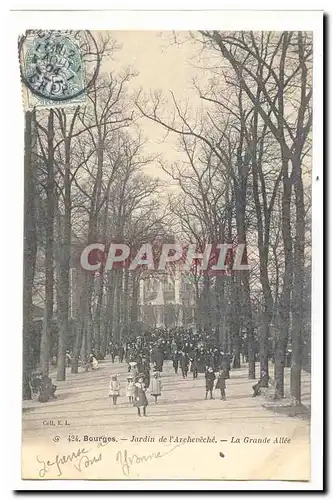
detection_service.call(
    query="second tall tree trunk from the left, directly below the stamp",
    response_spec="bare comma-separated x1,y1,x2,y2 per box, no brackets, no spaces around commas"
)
40,109,54,375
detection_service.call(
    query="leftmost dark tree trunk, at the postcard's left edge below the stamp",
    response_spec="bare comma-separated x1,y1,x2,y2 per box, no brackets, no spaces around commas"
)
22,111,37,399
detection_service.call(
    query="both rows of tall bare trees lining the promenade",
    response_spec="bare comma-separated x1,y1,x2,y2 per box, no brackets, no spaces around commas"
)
23,31,312,403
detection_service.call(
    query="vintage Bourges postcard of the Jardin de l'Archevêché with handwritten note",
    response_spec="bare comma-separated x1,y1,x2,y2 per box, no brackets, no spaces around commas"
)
11,8,322,488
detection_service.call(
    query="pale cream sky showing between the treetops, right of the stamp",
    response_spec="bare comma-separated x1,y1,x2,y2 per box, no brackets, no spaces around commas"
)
98,31,203,180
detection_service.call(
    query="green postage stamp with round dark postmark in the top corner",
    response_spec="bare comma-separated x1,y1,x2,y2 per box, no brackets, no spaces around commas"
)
19,30,99,109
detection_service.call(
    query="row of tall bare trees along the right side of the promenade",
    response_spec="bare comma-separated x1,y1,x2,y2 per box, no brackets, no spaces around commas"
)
136,31,312,403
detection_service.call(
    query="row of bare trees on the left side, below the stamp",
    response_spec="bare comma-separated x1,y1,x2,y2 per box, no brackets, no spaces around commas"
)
23,36,165,397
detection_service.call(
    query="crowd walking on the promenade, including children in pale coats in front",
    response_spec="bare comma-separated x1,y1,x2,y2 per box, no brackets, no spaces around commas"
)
105,328,233,416
